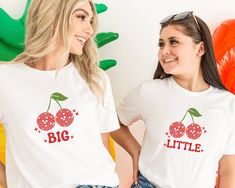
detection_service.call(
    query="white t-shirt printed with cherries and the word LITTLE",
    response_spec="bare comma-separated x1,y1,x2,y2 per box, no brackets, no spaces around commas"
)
118,78,235,188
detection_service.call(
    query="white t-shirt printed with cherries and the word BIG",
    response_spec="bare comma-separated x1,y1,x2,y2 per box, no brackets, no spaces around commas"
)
0,63,119,188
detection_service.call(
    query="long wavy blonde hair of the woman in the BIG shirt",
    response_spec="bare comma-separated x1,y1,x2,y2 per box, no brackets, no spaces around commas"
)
13,0,105,101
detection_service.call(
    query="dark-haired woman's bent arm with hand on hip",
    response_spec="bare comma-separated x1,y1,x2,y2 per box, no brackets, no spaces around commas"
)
110,123,141,184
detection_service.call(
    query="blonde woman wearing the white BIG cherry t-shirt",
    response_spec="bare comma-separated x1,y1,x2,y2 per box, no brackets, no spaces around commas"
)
0,0,119,188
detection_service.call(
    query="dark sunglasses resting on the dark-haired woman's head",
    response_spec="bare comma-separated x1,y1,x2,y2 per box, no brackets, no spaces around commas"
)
160,11,201,33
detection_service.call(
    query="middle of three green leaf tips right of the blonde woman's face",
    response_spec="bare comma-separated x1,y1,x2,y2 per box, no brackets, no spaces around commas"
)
95,32,119,48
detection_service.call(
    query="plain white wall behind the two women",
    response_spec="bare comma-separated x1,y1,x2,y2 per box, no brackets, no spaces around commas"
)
0,0,235,188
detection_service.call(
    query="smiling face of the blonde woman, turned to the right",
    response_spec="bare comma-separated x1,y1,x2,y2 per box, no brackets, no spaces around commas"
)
69,0,94,55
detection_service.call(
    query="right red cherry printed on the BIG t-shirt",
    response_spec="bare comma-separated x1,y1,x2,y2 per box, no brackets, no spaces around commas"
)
55,108,74,127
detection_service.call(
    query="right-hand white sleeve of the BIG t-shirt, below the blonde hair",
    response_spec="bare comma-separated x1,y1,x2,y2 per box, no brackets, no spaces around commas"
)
99,73,120,133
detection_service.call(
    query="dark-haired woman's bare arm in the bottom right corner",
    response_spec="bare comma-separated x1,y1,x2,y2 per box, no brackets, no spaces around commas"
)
218,155,235,188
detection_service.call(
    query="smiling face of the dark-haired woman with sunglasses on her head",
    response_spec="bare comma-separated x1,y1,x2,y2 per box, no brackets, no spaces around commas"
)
158,25,202,76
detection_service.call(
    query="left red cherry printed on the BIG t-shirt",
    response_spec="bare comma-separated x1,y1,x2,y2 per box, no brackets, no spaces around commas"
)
37,112,55,131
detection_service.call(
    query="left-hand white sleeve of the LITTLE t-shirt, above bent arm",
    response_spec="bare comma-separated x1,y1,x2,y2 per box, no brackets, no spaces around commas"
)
117,84,143,126
